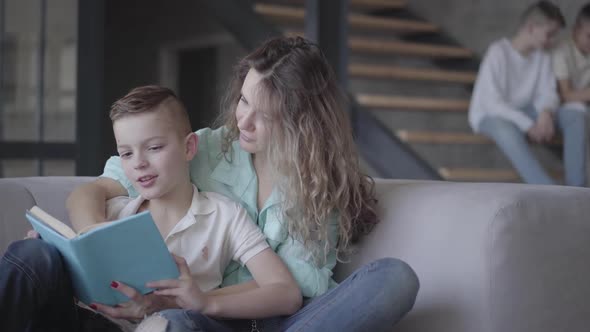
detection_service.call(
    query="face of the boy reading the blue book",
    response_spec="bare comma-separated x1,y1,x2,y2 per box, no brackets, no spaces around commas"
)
113,106,196,200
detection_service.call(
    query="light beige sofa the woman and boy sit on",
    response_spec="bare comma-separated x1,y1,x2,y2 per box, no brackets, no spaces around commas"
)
0,177,590,332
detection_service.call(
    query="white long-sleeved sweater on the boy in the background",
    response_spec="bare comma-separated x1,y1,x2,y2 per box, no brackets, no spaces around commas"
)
469,38,559,132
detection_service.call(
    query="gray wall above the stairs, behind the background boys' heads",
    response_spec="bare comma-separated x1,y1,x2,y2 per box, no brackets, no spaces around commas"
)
408,0,586,55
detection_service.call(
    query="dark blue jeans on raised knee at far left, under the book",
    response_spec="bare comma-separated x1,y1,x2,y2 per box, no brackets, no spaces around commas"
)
0,239,119,332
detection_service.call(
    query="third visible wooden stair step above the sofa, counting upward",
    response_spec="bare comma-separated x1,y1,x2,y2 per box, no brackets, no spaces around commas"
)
356,93,469,112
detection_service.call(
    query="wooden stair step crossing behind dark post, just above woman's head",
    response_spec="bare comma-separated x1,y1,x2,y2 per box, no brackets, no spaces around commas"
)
254,3,438,32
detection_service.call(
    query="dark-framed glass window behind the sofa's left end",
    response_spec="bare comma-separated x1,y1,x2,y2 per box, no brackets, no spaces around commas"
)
0,0,78,177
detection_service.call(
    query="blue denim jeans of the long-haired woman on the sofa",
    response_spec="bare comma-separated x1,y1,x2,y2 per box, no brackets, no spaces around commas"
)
160,258,419,332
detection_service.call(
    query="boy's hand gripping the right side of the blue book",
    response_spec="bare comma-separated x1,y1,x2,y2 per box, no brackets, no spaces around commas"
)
146,254,207,312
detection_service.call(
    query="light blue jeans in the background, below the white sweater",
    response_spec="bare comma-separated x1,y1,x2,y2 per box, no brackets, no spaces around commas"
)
479,105,587,186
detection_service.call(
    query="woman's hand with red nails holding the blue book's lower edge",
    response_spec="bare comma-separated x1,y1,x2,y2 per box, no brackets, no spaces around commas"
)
90,281,176,320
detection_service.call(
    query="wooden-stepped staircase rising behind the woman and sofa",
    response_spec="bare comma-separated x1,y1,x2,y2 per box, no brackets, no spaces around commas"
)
254,0,561,182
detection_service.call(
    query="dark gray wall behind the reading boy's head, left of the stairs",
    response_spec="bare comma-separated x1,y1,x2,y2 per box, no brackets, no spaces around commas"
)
102,0,243,160
